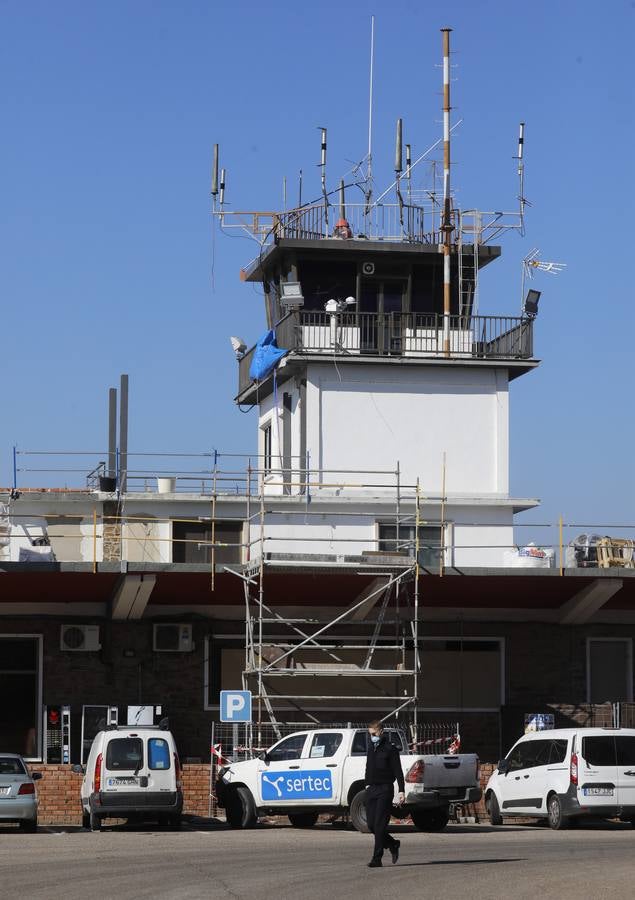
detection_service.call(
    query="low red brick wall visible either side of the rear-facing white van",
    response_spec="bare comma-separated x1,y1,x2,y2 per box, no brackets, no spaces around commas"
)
30,763,214,825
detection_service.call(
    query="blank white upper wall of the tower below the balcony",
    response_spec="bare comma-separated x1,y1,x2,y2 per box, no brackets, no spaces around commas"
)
307,364,509,496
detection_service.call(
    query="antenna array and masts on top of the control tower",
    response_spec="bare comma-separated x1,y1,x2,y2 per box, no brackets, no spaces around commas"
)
211,22,531,253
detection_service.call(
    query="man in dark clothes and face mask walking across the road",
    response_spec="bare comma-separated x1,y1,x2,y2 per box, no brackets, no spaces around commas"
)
365,720,406,869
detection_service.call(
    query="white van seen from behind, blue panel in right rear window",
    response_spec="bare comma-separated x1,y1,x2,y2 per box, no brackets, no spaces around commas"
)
73,723,183,831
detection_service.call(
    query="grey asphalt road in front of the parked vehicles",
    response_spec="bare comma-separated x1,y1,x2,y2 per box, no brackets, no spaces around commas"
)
0,824,635,900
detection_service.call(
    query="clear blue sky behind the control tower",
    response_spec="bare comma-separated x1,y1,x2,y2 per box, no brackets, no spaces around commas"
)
0,0,635,536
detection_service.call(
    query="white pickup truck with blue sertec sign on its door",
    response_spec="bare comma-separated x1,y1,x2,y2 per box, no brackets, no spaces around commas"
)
216,728,481,832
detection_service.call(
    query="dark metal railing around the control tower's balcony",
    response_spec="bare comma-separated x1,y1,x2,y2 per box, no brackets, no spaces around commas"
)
238,310,533,393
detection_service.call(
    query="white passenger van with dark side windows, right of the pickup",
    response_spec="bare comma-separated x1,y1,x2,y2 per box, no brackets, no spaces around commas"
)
485,728,635,828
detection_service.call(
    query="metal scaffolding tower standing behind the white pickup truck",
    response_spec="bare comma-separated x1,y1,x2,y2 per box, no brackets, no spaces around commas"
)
221,465,421,743
